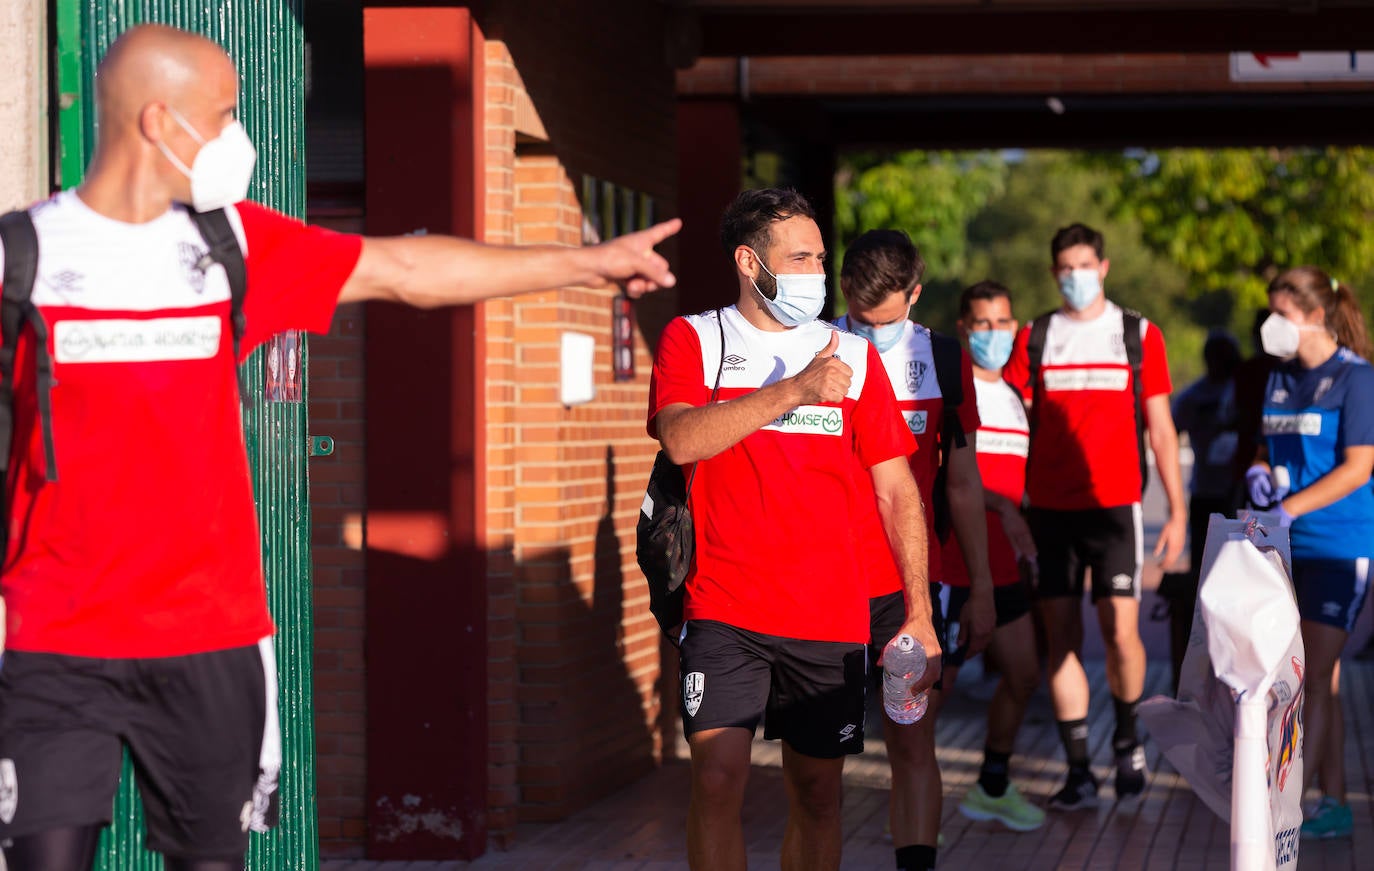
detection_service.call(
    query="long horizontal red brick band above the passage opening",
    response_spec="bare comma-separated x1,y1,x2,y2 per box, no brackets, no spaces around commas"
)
677,54,1367,96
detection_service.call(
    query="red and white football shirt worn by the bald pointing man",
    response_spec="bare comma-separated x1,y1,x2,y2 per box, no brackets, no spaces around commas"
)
0,191,361,657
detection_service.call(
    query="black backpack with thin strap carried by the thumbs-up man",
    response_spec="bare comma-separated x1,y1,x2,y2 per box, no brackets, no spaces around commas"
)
635,309,725,644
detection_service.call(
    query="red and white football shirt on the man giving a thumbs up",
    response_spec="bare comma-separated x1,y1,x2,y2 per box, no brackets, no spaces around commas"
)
649,306,914,643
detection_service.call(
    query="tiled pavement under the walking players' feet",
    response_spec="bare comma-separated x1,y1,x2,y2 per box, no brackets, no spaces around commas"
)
322,661,1374,871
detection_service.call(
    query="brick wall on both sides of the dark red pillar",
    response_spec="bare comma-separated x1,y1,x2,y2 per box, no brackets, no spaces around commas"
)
309,0,677,857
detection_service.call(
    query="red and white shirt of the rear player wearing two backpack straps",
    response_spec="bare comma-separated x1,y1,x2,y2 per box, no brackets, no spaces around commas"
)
1002,302,1173,511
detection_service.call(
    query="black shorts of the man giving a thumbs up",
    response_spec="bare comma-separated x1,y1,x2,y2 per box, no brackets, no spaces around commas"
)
679,620,866,758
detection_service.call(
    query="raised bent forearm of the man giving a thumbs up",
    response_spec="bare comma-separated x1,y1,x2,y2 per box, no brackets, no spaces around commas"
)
655,379,801,466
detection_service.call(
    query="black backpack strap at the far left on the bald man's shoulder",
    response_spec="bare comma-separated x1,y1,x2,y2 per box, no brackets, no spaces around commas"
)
0,210,58,481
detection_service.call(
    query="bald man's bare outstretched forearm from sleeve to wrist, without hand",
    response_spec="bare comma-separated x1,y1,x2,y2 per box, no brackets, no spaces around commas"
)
339,235,603,308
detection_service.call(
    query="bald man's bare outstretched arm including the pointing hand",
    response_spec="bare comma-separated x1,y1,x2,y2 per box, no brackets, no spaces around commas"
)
339,218,682,308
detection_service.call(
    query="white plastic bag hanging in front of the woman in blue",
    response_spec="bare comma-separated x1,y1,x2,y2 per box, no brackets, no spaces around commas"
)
1140,514,1304,871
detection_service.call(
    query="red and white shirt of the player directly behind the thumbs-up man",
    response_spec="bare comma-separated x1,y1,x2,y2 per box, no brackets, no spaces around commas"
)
837,316,978,596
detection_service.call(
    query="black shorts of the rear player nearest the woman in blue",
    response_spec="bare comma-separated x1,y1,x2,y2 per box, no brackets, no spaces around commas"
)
1026,503,1145,602
